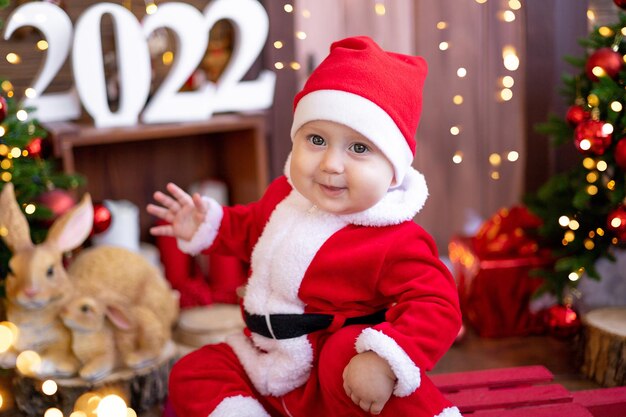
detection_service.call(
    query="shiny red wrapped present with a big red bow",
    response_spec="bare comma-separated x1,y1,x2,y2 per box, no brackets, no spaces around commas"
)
449,207,551,337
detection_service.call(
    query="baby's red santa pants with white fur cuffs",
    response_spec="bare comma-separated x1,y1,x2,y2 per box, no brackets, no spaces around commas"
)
169,326,460,417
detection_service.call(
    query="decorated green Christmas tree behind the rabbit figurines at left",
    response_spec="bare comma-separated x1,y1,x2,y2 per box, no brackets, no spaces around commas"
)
0,88,83,283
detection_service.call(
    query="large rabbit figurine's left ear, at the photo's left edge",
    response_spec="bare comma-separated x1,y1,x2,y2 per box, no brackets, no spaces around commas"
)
0,182,33,253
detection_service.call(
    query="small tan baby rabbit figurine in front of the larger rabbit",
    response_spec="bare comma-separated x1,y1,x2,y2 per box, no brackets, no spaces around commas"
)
61,296,130,381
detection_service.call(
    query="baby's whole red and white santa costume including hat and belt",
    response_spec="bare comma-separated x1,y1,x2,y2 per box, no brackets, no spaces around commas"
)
170,37,461,417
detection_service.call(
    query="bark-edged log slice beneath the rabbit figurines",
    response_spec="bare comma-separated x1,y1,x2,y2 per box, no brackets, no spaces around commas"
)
13,341,179,417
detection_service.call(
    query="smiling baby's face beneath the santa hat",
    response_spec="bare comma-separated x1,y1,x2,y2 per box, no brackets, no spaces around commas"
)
290,120,394,214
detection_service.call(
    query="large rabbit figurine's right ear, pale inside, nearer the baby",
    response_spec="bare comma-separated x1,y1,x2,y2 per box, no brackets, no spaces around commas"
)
46,194,93,252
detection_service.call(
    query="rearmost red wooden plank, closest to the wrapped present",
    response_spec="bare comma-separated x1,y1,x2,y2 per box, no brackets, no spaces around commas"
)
429,365,554,393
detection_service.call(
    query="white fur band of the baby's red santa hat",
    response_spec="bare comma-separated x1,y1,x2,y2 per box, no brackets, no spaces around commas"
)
291,90,413,184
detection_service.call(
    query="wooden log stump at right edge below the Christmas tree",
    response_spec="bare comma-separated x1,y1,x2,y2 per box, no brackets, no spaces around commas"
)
581,307,626,387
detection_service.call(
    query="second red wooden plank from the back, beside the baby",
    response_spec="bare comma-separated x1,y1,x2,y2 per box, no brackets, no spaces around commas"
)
444,384,572,413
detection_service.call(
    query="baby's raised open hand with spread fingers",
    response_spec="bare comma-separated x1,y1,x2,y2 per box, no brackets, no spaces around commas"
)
146,182,207,240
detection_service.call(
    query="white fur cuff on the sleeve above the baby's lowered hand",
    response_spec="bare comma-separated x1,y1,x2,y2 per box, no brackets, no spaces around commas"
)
356,328,420,394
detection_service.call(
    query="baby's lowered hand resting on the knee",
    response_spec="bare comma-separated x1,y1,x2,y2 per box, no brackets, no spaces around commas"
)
343,351,396,414
